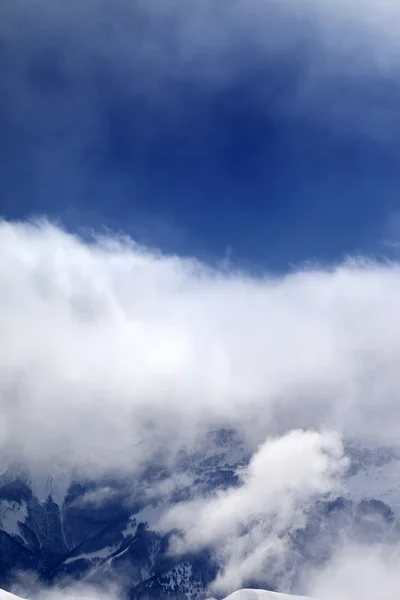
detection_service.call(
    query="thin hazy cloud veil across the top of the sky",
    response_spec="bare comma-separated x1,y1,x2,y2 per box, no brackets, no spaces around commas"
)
0,0,400,142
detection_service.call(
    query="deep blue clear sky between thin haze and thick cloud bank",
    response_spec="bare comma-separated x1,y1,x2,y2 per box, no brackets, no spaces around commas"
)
0,0,400,270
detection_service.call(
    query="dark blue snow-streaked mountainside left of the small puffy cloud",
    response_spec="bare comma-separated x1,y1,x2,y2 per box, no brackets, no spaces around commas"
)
0,432,248,600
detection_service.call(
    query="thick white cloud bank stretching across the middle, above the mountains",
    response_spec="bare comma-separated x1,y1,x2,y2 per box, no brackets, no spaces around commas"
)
0,222,400,469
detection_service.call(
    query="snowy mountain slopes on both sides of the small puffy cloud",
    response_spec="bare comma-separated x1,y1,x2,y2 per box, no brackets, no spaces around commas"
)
0,432,400,600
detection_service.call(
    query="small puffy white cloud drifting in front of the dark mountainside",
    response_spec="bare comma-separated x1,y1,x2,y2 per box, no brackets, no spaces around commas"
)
161,431,347,593
